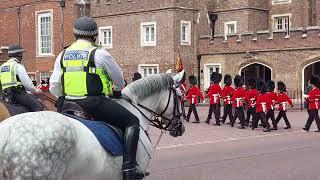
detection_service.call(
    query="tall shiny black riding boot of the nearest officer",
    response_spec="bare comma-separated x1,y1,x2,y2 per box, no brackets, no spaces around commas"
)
122,126,145,180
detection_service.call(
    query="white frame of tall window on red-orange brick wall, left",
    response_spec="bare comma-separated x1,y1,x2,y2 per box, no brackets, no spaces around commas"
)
35,9,54,57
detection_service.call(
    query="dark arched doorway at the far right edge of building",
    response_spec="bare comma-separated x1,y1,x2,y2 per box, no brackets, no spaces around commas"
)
302,60,320,92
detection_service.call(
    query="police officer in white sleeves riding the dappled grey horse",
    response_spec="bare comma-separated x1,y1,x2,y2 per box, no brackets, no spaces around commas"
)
50,16,144,180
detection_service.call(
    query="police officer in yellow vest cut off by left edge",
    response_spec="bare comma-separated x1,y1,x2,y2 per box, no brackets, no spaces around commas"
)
0,45,43,112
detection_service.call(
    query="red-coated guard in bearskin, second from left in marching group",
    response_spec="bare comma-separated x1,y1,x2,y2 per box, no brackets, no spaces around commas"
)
206,72,222,126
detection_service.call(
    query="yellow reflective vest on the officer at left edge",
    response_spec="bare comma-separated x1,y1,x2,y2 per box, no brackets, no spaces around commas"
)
0,59,22,90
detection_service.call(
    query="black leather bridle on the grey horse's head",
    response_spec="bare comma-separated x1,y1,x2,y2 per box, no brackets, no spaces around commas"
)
128,85,182,131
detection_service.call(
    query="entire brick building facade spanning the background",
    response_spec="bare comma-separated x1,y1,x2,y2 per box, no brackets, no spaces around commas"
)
0,0,320,98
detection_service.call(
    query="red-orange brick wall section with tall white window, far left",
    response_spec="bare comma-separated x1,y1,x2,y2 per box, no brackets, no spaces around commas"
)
0,0,89,82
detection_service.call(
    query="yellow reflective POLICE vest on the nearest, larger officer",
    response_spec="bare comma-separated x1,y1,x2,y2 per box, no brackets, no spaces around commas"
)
60,41,112,97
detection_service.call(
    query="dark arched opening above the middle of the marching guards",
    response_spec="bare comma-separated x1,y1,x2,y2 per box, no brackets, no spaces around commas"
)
239,62,272,82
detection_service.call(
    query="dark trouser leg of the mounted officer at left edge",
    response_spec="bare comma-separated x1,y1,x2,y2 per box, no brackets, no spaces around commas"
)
13,91,43,112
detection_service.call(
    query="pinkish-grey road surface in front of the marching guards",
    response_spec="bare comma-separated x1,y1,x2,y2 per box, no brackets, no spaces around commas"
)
148,108,320,180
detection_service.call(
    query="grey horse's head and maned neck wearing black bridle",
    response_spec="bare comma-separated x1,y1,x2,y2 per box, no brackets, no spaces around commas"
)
122,71,185,137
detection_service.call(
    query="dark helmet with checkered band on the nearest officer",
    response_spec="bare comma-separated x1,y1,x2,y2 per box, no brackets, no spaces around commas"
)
73,16,98,38
